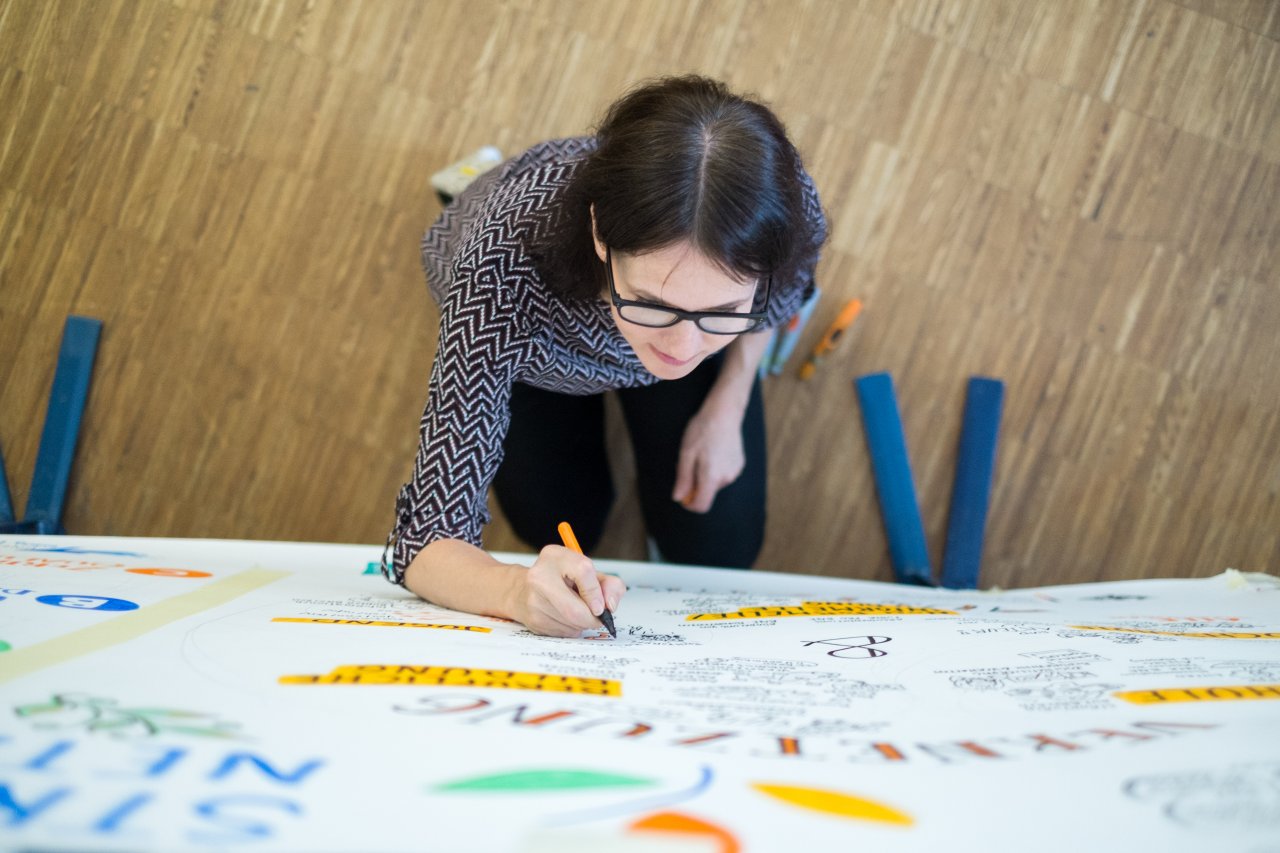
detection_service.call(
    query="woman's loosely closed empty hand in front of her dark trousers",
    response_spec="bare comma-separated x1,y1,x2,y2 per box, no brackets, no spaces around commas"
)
671,400,746,512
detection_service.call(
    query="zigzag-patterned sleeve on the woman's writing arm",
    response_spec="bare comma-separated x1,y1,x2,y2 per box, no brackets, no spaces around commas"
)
384,252,532,584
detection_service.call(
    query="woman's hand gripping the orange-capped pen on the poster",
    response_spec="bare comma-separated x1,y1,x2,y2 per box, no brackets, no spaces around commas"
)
512,546,626,637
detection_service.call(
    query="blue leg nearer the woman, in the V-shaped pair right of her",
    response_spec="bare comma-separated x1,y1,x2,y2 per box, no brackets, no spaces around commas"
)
854,373,933,587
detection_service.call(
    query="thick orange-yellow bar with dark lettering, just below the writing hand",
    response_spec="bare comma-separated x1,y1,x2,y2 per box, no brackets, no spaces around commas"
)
279,663,622,695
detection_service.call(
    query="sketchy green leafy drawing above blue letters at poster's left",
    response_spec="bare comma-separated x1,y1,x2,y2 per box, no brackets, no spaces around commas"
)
13,693,242,738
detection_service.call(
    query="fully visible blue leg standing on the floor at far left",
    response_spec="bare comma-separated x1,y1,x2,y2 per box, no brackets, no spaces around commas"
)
23,316,102,534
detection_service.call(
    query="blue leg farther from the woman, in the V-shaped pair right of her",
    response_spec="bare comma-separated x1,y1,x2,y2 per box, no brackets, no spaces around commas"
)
942,377,1005,589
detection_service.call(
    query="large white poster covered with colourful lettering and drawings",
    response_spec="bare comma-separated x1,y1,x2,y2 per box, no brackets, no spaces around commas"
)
0,537,1280,853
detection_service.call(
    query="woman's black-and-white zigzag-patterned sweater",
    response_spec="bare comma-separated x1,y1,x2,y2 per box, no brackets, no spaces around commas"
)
383,137,826,584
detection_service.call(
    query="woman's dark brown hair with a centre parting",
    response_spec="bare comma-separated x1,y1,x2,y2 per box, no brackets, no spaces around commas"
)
535,77,820,298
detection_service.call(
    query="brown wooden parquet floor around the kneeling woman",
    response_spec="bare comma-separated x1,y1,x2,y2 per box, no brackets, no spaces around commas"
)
0,0,1280,587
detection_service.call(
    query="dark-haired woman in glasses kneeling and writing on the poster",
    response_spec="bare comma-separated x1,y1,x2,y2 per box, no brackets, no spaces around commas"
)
384,77,826,637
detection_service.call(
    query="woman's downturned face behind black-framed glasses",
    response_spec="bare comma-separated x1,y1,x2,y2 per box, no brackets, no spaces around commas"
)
595,241,755,379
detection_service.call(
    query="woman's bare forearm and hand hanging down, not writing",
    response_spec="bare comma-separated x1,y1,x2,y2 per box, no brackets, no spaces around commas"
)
671,333,772,512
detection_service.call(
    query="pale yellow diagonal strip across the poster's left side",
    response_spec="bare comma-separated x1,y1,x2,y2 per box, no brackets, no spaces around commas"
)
0,569,288,684
